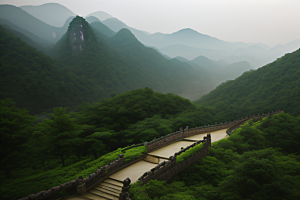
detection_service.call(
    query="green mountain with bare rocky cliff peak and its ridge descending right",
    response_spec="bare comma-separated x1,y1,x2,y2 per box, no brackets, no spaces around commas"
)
53,17,211,99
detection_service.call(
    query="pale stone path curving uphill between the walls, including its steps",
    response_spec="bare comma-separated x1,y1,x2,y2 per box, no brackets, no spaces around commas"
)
65,128,228,200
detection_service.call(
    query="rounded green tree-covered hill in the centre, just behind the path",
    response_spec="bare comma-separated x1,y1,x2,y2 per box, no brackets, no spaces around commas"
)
72,88,212,148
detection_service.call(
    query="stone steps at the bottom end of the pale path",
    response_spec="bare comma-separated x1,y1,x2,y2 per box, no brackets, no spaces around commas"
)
82,178,123,200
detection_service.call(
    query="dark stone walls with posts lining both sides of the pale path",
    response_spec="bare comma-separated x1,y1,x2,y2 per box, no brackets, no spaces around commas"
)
19,111,281,200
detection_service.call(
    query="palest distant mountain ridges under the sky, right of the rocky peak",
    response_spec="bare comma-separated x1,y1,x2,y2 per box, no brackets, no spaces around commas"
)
92,15,300,68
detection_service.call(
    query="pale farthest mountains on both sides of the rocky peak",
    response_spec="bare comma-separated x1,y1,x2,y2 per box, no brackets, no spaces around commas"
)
0,3,300,68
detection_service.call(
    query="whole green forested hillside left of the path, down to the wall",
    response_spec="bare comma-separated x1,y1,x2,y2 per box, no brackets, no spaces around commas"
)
0,88,214,199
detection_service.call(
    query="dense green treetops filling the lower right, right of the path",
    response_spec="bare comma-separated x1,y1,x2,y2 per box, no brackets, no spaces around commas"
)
130,113,300,200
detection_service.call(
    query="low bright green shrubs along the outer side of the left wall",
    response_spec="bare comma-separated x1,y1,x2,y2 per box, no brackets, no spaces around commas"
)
0,146,147,200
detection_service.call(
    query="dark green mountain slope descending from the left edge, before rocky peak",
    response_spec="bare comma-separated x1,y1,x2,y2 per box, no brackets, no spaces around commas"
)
0,26,103,114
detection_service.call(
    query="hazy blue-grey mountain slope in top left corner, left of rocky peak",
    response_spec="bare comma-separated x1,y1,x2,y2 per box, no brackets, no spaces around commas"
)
0,5,72,43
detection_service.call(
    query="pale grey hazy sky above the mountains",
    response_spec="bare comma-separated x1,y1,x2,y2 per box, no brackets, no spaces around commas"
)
0,0,300,46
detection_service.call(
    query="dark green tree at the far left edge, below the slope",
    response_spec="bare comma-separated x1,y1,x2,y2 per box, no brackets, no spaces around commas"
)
0,99,37,178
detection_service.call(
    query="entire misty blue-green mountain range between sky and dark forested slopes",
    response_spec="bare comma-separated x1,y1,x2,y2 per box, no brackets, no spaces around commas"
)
0,3,300,111
